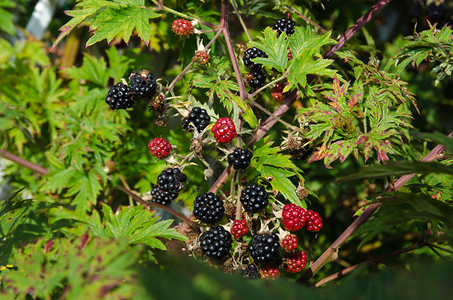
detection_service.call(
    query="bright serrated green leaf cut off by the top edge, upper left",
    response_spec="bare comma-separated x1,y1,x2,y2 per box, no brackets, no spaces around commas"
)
51,0,160,51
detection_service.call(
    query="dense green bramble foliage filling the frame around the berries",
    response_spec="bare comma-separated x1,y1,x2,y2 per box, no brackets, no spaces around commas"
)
0,0,453,299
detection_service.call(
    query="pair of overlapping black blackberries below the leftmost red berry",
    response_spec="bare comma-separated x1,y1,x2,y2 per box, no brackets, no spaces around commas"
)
151,168,187,205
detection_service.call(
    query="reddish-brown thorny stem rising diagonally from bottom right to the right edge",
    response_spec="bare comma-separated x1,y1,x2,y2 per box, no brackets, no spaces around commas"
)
297,132,453,282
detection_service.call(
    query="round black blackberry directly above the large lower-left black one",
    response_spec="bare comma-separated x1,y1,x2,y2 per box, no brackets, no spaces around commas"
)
193,193,225,225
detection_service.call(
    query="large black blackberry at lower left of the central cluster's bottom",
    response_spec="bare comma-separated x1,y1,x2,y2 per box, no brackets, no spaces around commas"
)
199,226,233,261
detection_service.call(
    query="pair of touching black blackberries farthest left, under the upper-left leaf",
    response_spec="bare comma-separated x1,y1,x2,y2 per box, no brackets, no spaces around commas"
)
105,71,157,110
